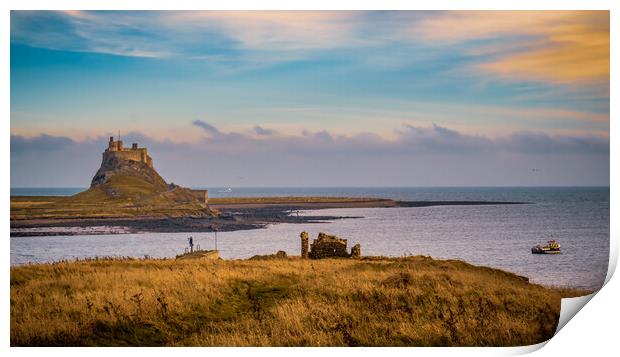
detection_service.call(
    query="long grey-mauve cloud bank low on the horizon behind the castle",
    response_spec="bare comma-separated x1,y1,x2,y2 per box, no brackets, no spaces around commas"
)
11,121,609,187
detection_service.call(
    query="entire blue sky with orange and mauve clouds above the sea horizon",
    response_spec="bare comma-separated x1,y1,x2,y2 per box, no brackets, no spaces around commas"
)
10,11,610,187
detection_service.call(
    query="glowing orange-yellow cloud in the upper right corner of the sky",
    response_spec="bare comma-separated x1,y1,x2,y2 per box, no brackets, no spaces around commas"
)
412,11,609,86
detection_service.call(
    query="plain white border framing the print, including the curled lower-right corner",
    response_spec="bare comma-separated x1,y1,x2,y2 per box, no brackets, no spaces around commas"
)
0,0,620,356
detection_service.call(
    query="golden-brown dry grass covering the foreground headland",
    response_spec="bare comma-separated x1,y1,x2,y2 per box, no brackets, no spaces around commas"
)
10,257,586,346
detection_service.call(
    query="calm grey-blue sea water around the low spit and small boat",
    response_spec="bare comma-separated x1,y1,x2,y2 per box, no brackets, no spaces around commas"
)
11,187,609,288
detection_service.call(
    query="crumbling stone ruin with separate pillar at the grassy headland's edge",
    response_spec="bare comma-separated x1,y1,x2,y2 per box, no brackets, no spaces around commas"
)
300,232,362,259
